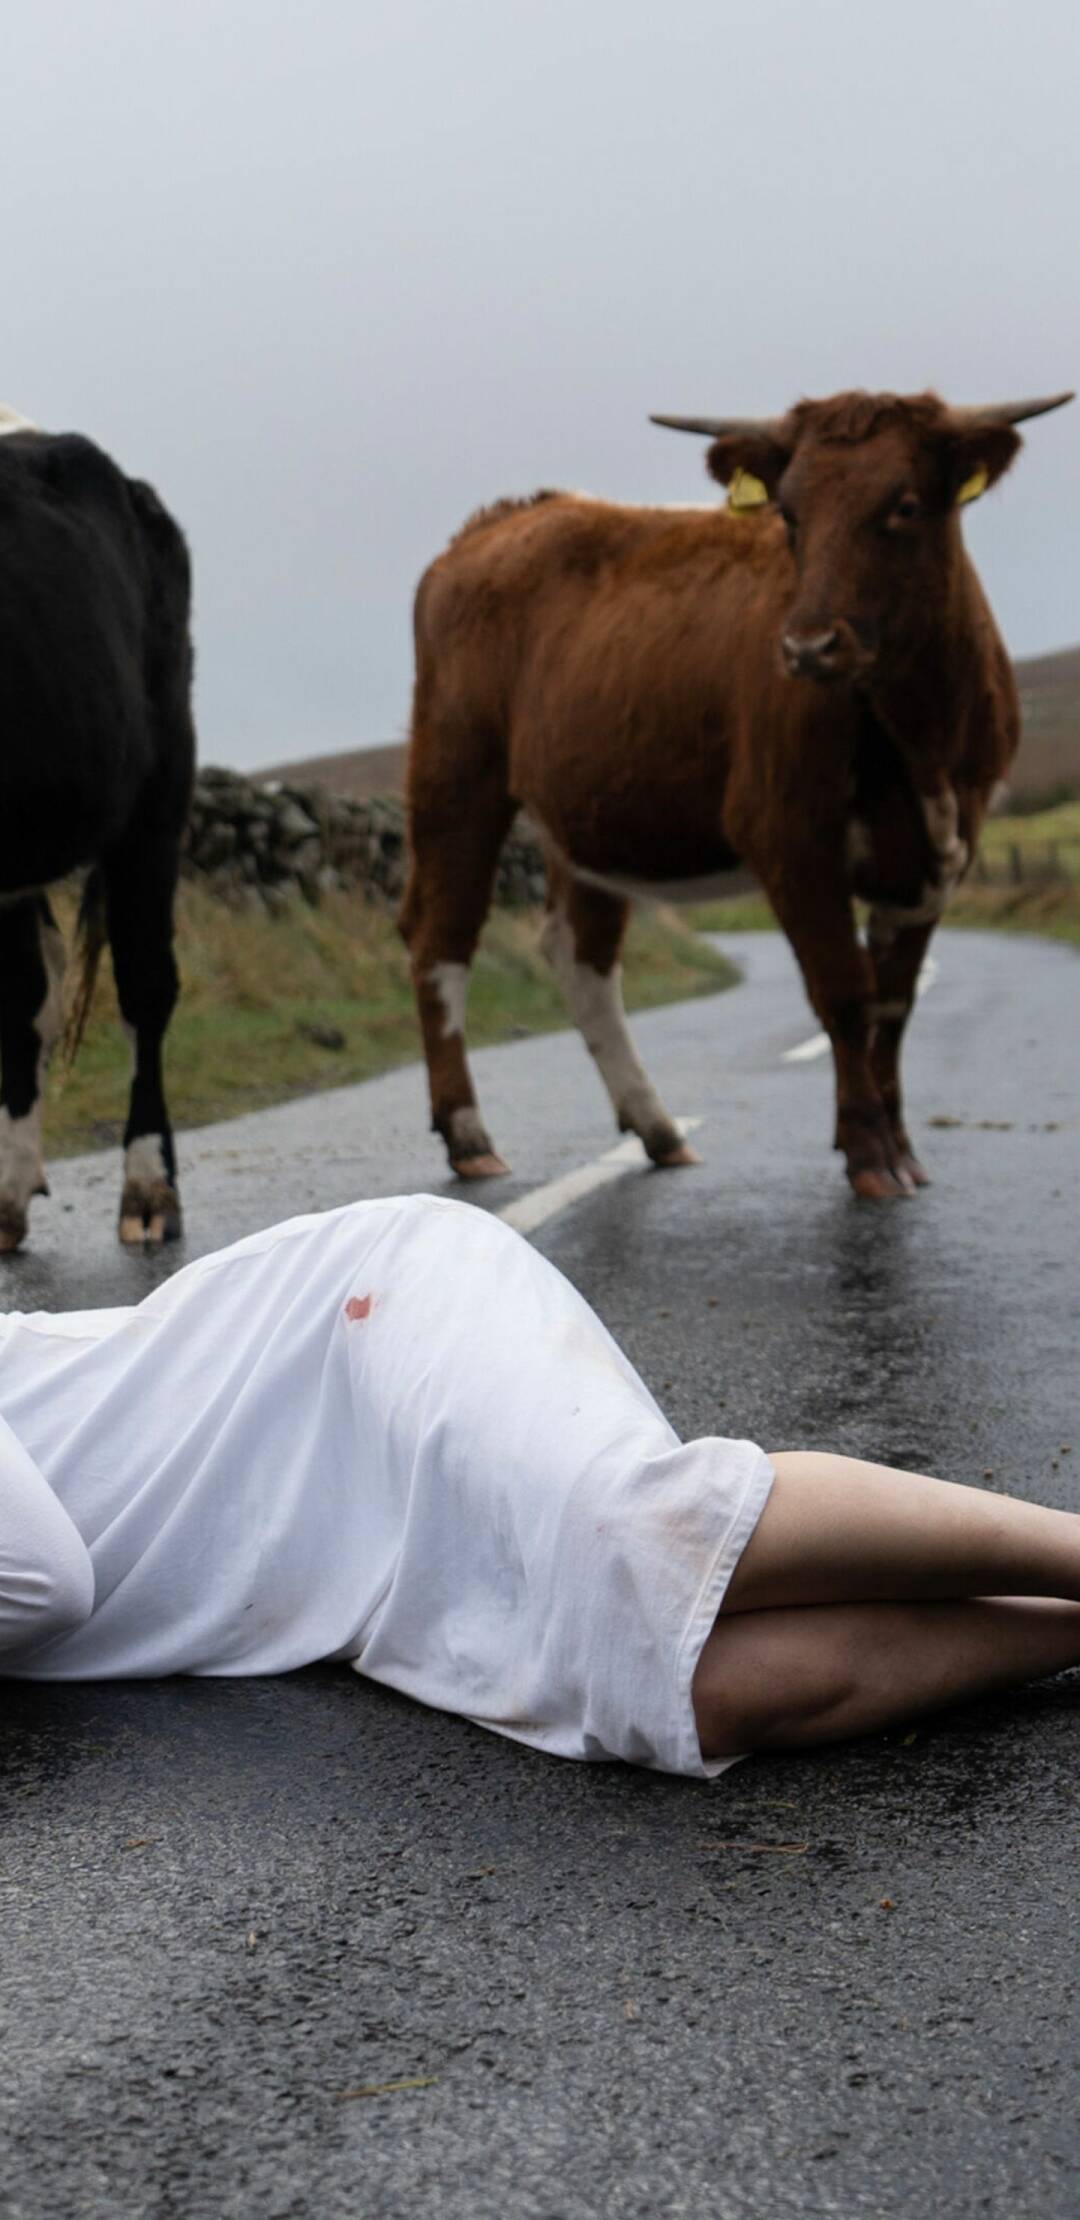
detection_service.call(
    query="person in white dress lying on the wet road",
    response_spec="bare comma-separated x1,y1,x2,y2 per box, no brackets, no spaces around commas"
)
0,1197,1080,1776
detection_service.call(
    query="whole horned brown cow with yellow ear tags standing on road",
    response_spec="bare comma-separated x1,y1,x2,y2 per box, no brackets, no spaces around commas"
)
400,393,1071,1199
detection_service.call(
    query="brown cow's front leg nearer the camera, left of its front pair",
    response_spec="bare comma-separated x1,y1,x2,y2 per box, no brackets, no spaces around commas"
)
769,864,916,1203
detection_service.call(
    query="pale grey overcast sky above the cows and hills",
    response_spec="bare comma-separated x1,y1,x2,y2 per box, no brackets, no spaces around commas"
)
0,0,1080,764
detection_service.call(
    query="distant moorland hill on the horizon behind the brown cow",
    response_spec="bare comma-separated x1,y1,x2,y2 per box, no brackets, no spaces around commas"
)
260,648,1080,808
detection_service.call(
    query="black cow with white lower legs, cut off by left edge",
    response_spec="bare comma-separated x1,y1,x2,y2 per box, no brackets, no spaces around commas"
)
0,408,196,1250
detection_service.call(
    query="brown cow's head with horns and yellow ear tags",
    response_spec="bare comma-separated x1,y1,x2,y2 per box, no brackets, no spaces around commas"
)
653,393,1073,682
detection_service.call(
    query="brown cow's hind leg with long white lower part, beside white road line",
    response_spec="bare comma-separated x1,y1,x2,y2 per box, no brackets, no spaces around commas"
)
540,861,700,1168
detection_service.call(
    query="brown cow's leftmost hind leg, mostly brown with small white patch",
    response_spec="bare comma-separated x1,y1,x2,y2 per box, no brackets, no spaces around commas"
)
398,779,513,1179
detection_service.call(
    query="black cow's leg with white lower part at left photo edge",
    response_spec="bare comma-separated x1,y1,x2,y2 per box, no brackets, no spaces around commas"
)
0,895,64,1252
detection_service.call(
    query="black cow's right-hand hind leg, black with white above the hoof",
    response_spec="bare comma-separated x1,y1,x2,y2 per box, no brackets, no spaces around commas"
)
102,833,180,1245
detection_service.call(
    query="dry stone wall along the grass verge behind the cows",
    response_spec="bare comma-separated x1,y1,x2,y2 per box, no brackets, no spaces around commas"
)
184,766,544,910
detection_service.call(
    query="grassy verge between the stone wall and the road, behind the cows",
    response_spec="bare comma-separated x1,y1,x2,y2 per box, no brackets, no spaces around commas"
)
44,884,736,1157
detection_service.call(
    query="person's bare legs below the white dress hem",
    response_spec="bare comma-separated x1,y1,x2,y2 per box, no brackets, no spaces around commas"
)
693,1452,1080,1756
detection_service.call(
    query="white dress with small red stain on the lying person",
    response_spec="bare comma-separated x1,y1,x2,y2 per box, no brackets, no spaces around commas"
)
0,1197,771,1776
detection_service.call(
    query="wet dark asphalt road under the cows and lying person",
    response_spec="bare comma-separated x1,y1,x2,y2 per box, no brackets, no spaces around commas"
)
0,935,1080,2220
